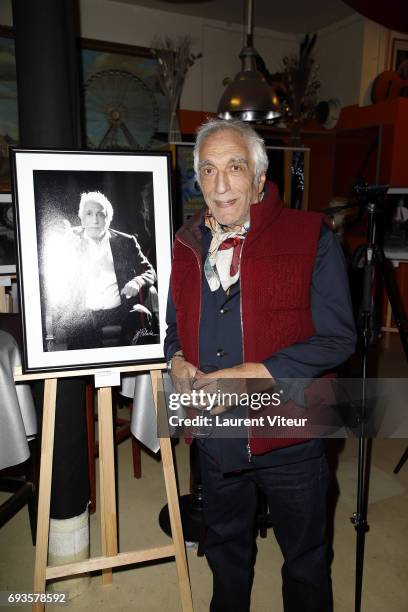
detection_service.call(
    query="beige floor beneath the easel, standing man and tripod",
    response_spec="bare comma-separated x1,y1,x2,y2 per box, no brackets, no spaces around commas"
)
0,338,408,612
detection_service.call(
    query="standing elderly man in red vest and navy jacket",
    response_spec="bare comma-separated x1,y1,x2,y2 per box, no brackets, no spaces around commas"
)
165,120,355,612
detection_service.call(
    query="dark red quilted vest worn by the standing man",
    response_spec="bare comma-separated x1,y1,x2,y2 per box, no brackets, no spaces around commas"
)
171,184,323,454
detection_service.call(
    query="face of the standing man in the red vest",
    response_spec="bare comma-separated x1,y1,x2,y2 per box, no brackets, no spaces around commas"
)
199,128,265,229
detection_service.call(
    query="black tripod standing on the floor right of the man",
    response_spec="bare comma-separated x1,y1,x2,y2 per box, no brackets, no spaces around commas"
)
351,185,408,612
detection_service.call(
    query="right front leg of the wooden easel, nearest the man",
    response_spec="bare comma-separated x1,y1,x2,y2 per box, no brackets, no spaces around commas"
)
150,370,193,612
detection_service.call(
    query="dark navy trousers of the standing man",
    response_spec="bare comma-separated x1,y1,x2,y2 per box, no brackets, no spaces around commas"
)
200,451,332,612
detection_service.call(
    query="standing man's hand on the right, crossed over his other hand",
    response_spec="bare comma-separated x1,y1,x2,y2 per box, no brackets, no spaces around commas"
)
192,362,275,415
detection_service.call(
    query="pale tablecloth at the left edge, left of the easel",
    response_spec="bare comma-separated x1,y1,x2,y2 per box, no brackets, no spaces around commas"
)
0,330,37,469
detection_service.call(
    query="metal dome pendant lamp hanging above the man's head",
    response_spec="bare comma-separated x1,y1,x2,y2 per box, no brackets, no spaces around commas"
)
217,0,281,121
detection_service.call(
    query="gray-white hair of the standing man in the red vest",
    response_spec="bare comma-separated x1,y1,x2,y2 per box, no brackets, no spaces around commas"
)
194,119,269,183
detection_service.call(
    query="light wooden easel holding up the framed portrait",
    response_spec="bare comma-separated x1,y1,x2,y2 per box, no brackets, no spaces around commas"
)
14,363,193,612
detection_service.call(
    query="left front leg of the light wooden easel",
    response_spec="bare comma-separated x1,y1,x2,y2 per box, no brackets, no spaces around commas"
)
33,378,57,611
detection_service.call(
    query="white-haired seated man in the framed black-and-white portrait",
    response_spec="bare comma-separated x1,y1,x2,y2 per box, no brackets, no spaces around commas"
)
47,191,156,349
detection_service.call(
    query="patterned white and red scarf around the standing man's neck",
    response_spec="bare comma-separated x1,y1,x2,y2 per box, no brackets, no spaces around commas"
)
204,217,249,291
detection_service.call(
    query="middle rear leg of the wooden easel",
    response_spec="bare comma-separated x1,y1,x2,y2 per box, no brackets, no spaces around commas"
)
98,387,118,585
